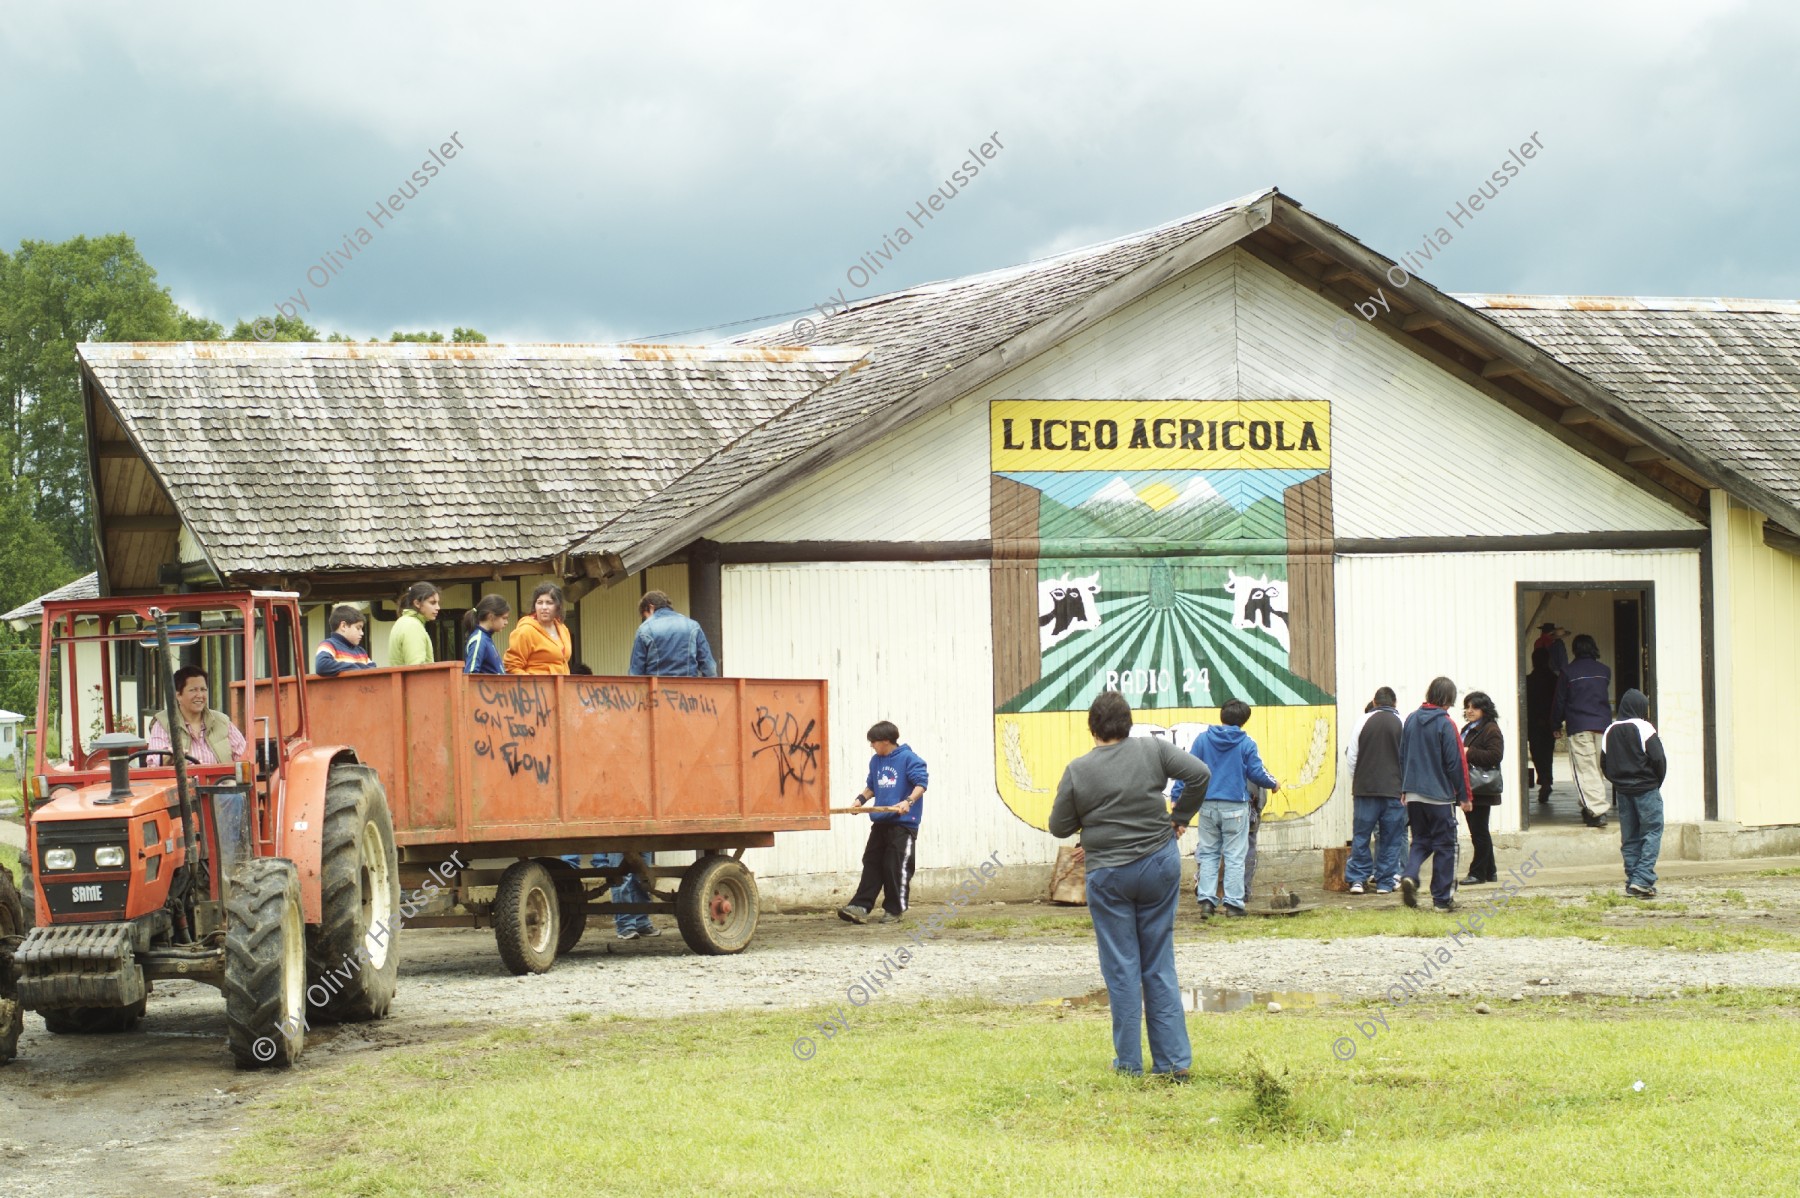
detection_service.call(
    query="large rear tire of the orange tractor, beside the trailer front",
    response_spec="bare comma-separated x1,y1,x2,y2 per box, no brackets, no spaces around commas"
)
306,761,400,1024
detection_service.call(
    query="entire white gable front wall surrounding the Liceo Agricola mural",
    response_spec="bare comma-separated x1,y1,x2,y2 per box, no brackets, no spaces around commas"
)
709,252,1701,901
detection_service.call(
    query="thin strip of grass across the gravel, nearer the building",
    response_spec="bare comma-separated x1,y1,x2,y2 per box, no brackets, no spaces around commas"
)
945,889,1800,952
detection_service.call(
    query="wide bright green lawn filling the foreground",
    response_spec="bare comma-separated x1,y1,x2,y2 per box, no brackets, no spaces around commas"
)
218,991,1800,1198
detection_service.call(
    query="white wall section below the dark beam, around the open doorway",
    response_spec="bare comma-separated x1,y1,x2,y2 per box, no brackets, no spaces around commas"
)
1321,549,1705,831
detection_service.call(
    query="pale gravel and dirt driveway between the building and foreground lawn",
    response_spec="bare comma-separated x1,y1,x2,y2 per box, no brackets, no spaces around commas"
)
0,874,1800,1198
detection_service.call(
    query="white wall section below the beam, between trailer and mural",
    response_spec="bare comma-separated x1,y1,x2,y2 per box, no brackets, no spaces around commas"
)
724,563,1057,876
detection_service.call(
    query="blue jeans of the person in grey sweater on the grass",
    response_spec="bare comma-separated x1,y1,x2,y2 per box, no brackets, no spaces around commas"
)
1087,838,1193,1074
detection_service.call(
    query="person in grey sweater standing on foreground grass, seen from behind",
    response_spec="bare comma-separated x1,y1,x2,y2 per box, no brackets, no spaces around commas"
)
1049,691,1211,1081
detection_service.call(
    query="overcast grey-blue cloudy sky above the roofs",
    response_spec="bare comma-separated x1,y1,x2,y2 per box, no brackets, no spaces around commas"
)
0,0,1800,340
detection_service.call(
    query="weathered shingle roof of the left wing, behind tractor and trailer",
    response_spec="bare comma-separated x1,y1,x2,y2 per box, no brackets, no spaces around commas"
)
81,344,862,590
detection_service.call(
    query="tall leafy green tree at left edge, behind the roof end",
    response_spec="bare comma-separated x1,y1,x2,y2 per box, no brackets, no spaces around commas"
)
0,234,207,572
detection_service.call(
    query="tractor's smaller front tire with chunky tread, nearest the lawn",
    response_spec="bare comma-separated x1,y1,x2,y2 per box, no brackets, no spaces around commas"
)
221,856,306,1068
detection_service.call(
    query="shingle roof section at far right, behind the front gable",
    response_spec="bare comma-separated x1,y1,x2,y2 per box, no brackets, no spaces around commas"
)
1456,295,1800,532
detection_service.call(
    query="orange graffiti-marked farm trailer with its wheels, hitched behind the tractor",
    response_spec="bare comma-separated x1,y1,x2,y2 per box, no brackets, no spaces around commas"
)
298,662,830,973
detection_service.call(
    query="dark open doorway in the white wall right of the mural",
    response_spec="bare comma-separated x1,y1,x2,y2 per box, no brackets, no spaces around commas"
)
1512,583,1656,827
